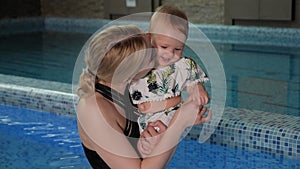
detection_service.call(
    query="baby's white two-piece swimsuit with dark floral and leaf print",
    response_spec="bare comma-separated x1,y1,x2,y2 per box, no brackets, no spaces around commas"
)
129,57,208,131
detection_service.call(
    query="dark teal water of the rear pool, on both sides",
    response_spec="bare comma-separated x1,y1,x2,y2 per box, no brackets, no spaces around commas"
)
0,32,300,116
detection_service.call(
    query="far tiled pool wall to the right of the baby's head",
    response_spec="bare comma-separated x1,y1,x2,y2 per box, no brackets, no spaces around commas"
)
195,25,300,47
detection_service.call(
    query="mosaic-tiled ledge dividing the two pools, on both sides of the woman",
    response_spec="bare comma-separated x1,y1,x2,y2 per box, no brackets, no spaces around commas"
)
0,83,300,159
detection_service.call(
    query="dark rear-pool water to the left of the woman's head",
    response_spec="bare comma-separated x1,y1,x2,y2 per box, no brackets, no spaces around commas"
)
0,32,90,83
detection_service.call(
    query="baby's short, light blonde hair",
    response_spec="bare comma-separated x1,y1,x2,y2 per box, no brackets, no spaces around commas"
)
149,5,189,37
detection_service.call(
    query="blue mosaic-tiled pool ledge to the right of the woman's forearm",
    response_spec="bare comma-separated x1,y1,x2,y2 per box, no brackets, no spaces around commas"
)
187,108,300,158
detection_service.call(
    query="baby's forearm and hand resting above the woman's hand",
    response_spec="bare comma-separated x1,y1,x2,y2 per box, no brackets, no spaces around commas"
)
186,83,210,106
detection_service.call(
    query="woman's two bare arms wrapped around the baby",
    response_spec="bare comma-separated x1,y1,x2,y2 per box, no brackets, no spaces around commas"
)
77,93,208,169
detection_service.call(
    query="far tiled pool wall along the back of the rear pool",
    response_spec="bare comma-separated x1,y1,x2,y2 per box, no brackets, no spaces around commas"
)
0,17,300,47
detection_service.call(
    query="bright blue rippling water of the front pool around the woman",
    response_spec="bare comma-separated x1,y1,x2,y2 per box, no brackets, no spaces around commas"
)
0,105,300,169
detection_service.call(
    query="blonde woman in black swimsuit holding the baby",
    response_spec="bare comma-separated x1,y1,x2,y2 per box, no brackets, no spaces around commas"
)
77,26,208,169
